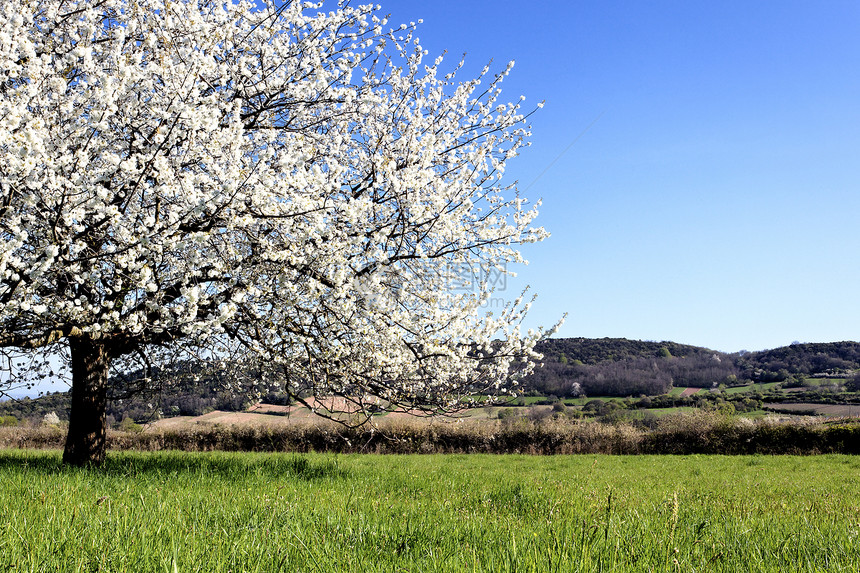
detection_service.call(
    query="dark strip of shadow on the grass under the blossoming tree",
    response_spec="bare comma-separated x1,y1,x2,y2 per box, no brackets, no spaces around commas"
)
0,450,348,481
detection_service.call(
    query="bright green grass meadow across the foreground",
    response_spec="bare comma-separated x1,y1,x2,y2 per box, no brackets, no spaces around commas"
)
0,450,860,572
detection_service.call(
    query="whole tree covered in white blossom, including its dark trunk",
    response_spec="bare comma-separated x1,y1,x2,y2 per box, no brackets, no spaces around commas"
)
0,0,545,464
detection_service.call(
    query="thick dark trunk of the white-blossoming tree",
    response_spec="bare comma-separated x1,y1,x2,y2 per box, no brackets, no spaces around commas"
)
63,338,110,466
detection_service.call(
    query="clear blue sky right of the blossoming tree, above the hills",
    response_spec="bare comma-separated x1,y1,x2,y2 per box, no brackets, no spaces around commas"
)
382,0,860,352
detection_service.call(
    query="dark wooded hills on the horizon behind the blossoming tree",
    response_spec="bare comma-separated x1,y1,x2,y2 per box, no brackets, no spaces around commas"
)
0,338,860,423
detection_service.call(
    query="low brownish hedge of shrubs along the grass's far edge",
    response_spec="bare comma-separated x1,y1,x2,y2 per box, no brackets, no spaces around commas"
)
0,412,860,455
